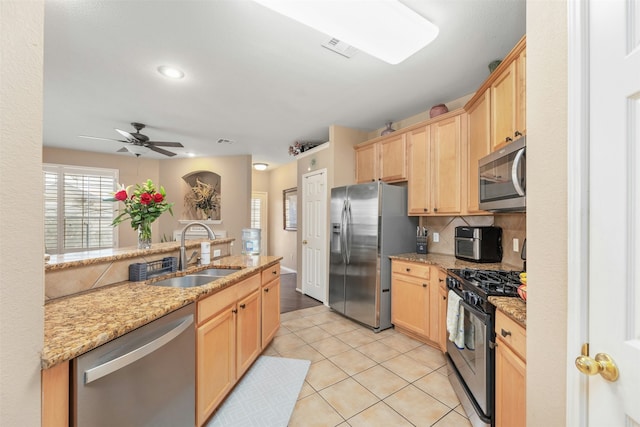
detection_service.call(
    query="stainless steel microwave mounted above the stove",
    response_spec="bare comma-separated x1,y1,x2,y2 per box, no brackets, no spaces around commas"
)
478,136,527,212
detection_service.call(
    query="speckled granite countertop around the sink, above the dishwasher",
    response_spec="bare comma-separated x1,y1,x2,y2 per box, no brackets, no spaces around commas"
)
42,254,282,369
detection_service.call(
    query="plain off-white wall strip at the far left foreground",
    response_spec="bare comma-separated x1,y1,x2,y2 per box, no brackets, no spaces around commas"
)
0,0,44,426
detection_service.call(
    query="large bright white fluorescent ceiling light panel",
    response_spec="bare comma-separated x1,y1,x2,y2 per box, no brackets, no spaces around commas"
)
254,0,439,64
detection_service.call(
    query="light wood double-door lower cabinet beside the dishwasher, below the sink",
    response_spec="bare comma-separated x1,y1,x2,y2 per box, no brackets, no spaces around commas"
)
196,273,261,426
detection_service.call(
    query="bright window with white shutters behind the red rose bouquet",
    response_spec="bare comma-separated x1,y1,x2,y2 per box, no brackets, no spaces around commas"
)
43,164,118,254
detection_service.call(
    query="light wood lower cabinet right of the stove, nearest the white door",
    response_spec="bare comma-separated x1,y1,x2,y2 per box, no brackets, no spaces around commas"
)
496,310,527,427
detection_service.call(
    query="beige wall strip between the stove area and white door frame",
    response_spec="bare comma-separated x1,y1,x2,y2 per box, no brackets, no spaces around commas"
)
527,0,568,426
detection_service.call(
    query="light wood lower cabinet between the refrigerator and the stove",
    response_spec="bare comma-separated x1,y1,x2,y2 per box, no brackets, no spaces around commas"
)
391,260,447,348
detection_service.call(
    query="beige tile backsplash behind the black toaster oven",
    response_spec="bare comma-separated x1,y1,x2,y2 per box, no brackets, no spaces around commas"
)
420,213,527,268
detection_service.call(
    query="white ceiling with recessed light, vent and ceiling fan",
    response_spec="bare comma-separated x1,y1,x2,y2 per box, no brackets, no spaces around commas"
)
44,0,525,166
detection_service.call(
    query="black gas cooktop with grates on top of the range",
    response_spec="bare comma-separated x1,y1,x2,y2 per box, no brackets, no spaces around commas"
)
447,268,521,311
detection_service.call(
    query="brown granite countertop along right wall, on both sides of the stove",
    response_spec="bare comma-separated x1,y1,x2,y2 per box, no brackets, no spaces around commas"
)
389,253,527,328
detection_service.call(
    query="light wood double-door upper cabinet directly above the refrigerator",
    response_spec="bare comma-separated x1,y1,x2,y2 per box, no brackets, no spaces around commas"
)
355,132,407,183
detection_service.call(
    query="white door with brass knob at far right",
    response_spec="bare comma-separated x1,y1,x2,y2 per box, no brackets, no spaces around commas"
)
588,0,640,427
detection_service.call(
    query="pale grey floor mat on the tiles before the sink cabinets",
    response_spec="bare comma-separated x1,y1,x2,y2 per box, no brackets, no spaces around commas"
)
207,356,311,427
